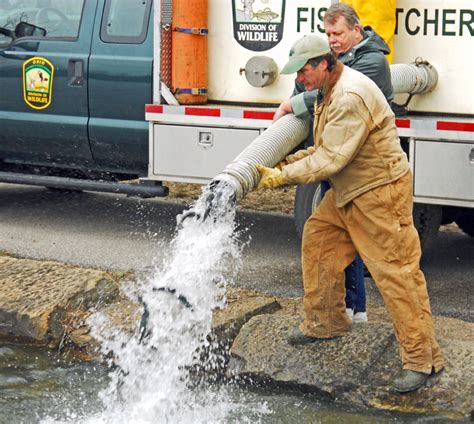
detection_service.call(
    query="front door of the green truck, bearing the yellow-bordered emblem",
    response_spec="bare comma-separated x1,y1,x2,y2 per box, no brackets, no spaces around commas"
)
0,0,97,167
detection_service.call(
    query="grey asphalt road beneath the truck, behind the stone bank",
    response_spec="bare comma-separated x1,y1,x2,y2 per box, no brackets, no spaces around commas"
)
0,184,474,322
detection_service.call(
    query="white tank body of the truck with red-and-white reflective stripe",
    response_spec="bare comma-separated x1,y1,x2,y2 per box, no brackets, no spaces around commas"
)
146,0,474,255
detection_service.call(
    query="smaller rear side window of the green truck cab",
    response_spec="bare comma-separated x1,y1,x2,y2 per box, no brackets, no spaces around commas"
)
100,0,151,44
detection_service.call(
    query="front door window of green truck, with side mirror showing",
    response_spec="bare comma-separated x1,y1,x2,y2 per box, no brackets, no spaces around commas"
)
0,0,84,40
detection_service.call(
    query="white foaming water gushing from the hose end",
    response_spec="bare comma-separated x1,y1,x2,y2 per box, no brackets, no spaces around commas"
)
54,185,262,423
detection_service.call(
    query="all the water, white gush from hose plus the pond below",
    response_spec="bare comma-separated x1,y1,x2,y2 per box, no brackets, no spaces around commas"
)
0,184,444,424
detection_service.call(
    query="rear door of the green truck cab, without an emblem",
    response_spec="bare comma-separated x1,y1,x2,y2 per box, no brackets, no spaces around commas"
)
89,0,153,175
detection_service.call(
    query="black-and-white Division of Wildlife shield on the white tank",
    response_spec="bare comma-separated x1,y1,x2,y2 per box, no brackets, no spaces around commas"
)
232,0,285,52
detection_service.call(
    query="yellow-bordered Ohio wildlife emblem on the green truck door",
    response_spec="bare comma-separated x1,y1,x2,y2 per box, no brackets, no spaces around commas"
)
23,57,54,110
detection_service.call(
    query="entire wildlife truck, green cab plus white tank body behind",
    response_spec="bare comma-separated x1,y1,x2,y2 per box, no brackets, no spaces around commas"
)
0,0,474,252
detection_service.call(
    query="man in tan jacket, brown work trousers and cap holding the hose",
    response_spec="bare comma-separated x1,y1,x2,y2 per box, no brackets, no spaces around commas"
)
257,36,443,392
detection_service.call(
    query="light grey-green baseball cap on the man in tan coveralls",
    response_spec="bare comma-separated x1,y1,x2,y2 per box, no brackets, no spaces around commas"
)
280,35,331,74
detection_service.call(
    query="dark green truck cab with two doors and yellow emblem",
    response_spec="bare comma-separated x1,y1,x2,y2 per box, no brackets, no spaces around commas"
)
0,0,165,195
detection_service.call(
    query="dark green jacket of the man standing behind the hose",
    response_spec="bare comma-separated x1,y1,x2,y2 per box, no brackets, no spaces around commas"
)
290,26,393,117
